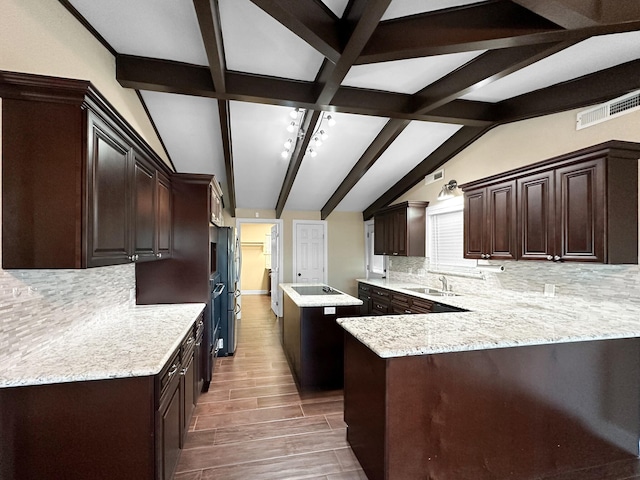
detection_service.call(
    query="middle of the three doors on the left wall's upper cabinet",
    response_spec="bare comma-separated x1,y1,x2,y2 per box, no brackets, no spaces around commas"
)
133,159,156,260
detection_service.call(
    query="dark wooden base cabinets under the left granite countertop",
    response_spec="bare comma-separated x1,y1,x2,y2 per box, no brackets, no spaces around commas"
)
0,318,201,480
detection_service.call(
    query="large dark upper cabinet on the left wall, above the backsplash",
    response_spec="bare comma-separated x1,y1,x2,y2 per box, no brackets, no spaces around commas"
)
0,72,171,269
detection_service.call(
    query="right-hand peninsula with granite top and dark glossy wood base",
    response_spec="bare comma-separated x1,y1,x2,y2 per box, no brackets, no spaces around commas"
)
338,281,640,480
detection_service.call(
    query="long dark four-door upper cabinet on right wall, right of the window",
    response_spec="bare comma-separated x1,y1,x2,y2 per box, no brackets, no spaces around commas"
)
462,141,640,264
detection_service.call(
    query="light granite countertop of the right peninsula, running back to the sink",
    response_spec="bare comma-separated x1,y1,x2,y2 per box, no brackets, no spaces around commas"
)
338,280,640,358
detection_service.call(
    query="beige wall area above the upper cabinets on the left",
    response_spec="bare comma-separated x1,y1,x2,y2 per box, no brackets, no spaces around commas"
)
0,0,168,164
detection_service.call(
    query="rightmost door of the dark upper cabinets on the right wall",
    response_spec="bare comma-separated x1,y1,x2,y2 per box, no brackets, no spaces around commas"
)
555,159,605,262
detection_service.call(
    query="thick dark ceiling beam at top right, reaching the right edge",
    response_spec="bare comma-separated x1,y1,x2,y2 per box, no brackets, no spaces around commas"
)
356,0,640,64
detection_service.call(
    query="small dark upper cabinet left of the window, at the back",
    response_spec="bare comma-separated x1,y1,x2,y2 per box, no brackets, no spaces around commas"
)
373,201,429,257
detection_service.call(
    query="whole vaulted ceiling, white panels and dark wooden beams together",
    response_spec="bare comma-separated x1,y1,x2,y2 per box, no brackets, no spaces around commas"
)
59,0,640,219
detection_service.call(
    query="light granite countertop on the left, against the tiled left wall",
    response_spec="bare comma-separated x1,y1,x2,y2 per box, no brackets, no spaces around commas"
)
0,303,205,388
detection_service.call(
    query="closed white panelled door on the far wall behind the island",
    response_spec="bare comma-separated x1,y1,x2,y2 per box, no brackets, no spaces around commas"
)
293,222,326,283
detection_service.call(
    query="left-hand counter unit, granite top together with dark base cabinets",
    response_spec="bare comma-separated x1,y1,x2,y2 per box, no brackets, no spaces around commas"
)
0,304,205,480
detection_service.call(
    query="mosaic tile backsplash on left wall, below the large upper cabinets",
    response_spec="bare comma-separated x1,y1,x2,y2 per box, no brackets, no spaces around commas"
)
0,264,135,368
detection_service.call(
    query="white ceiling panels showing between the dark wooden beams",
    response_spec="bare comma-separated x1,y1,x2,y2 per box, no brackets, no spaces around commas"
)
63,0,640,217
